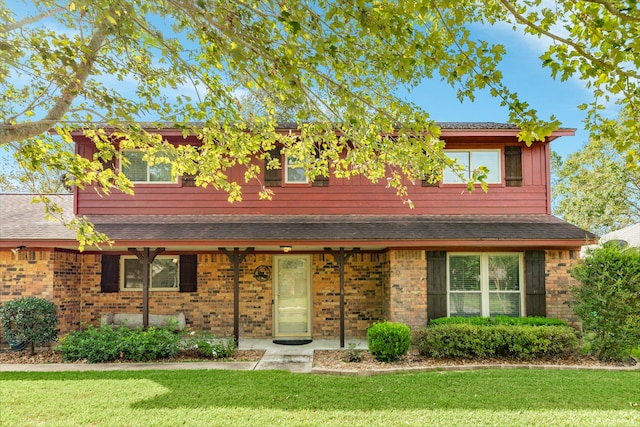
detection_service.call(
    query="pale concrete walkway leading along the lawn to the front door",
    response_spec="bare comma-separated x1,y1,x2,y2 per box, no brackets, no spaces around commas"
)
0,339,367,373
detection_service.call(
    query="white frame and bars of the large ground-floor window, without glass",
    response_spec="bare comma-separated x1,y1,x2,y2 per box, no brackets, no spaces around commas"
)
447,252,526,317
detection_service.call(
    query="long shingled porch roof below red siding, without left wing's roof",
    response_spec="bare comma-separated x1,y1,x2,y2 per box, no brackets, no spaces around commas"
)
84,215,595,251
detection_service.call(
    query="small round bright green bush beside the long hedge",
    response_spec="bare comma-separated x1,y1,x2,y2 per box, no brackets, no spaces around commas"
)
367,322,411,362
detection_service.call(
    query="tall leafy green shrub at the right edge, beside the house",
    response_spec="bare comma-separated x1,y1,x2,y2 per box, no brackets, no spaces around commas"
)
571,244,640,360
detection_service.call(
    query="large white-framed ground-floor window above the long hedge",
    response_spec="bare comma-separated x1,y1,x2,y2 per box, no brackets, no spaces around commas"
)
447,253,523,317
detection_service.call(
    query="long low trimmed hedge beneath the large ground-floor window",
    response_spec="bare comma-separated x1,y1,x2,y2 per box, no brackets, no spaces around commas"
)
414,324,579,360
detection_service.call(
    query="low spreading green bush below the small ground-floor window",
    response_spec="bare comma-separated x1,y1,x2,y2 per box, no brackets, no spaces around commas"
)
58,325,180,363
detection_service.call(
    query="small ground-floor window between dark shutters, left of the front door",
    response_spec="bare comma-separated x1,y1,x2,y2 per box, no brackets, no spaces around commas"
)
120,256,180,290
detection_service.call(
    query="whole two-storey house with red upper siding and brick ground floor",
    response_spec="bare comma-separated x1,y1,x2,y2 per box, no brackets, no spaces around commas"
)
0,123,595,344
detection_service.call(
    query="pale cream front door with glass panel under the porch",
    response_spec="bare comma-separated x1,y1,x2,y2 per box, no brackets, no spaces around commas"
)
273,255,311,338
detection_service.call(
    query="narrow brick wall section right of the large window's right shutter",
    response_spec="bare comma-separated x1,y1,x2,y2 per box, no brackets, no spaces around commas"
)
545,250,580,326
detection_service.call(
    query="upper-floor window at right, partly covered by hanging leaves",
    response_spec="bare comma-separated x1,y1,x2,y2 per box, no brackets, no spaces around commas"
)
442,150,502,184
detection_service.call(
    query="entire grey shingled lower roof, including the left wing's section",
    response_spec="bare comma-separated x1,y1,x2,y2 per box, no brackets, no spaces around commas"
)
0,195,596,250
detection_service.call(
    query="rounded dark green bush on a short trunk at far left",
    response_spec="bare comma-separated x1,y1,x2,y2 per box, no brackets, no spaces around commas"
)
0,297,58,354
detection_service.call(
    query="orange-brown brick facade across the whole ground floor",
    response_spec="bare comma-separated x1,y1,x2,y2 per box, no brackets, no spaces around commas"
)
0,249,579,339
